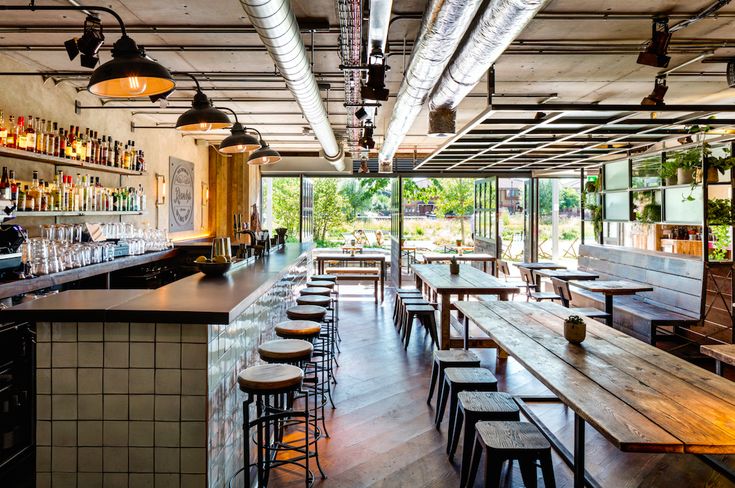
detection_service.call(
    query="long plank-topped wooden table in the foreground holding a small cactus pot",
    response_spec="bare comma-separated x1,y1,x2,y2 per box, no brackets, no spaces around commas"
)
456,302,735,487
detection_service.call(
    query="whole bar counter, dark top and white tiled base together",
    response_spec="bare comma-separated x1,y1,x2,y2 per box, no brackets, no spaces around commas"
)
0,244,312,488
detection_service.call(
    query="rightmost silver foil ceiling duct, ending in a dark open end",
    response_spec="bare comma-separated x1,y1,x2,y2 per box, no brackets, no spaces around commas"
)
429,0,548,136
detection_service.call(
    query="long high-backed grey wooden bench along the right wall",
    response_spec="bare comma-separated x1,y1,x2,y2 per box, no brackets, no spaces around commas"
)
571,245,704,344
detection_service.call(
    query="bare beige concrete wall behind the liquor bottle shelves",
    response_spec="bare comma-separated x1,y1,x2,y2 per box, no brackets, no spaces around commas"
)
0,53,209,239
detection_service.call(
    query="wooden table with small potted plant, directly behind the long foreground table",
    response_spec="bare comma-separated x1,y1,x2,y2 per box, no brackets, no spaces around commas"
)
413,264,520,349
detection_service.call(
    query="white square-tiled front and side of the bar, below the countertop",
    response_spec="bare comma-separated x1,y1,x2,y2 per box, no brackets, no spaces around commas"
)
20,246,310,488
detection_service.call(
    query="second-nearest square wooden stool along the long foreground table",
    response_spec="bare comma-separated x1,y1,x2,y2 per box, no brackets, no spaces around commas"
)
447,391,521,486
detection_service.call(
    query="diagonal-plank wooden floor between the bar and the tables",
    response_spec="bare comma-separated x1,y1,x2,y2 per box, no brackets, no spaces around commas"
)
270,286,735,488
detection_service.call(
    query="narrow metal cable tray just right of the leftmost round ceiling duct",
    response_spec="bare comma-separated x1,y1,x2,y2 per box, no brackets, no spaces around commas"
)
337,0,362,151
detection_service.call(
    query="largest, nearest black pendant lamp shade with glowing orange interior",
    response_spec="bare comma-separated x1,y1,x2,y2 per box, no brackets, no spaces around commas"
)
87,35,176,98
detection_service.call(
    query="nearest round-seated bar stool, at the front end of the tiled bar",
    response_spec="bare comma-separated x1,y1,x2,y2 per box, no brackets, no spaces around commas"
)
239,364,314,487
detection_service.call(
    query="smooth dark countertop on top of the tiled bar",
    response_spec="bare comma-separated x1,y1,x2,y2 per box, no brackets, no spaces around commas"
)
0,243,313,324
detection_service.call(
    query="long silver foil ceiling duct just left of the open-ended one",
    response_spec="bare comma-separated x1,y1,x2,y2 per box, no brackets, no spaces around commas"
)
380,0,481,169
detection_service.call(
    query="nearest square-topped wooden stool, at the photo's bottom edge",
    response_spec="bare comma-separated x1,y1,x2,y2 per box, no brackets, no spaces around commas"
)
465,422,556,488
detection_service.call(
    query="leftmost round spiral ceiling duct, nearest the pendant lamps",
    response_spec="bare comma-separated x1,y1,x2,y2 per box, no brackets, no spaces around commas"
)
240,0,345,171
